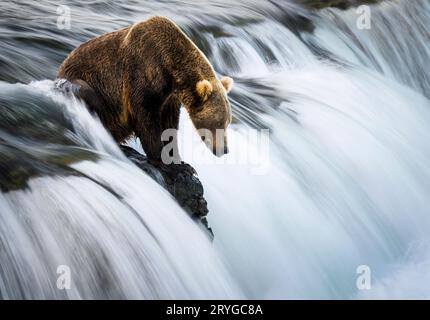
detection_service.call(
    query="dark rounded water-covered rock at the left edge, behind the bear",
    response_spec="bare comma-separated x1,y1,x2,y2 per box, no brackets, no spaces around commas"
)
0,83,98,192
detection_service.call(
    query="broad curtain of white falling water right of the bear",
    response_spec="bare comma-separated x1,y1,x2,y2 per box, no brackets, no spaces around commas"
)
183,2,430,298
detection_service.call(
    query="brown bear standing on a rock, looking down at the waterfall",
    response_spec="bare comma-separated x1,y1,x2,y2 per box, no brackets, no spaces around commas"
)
58,17,233,162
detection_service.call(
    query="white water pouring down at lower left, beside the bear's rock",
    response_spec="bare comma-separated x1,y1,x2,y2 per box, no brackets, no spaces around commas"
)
0,82,241,299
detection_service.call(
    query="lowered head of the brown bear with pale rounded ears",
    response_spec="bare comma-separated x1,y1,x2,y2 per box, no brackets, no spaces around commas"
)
185,77,233,157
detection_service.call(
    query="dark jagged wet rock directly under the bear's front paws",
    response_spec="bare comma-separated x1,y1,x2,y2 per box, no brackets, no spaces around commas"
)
120,146,213,236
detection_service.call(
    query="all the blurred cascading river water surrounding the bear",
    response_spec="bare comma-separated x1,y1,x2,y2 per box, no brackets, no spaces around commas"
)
0,0,430,299
